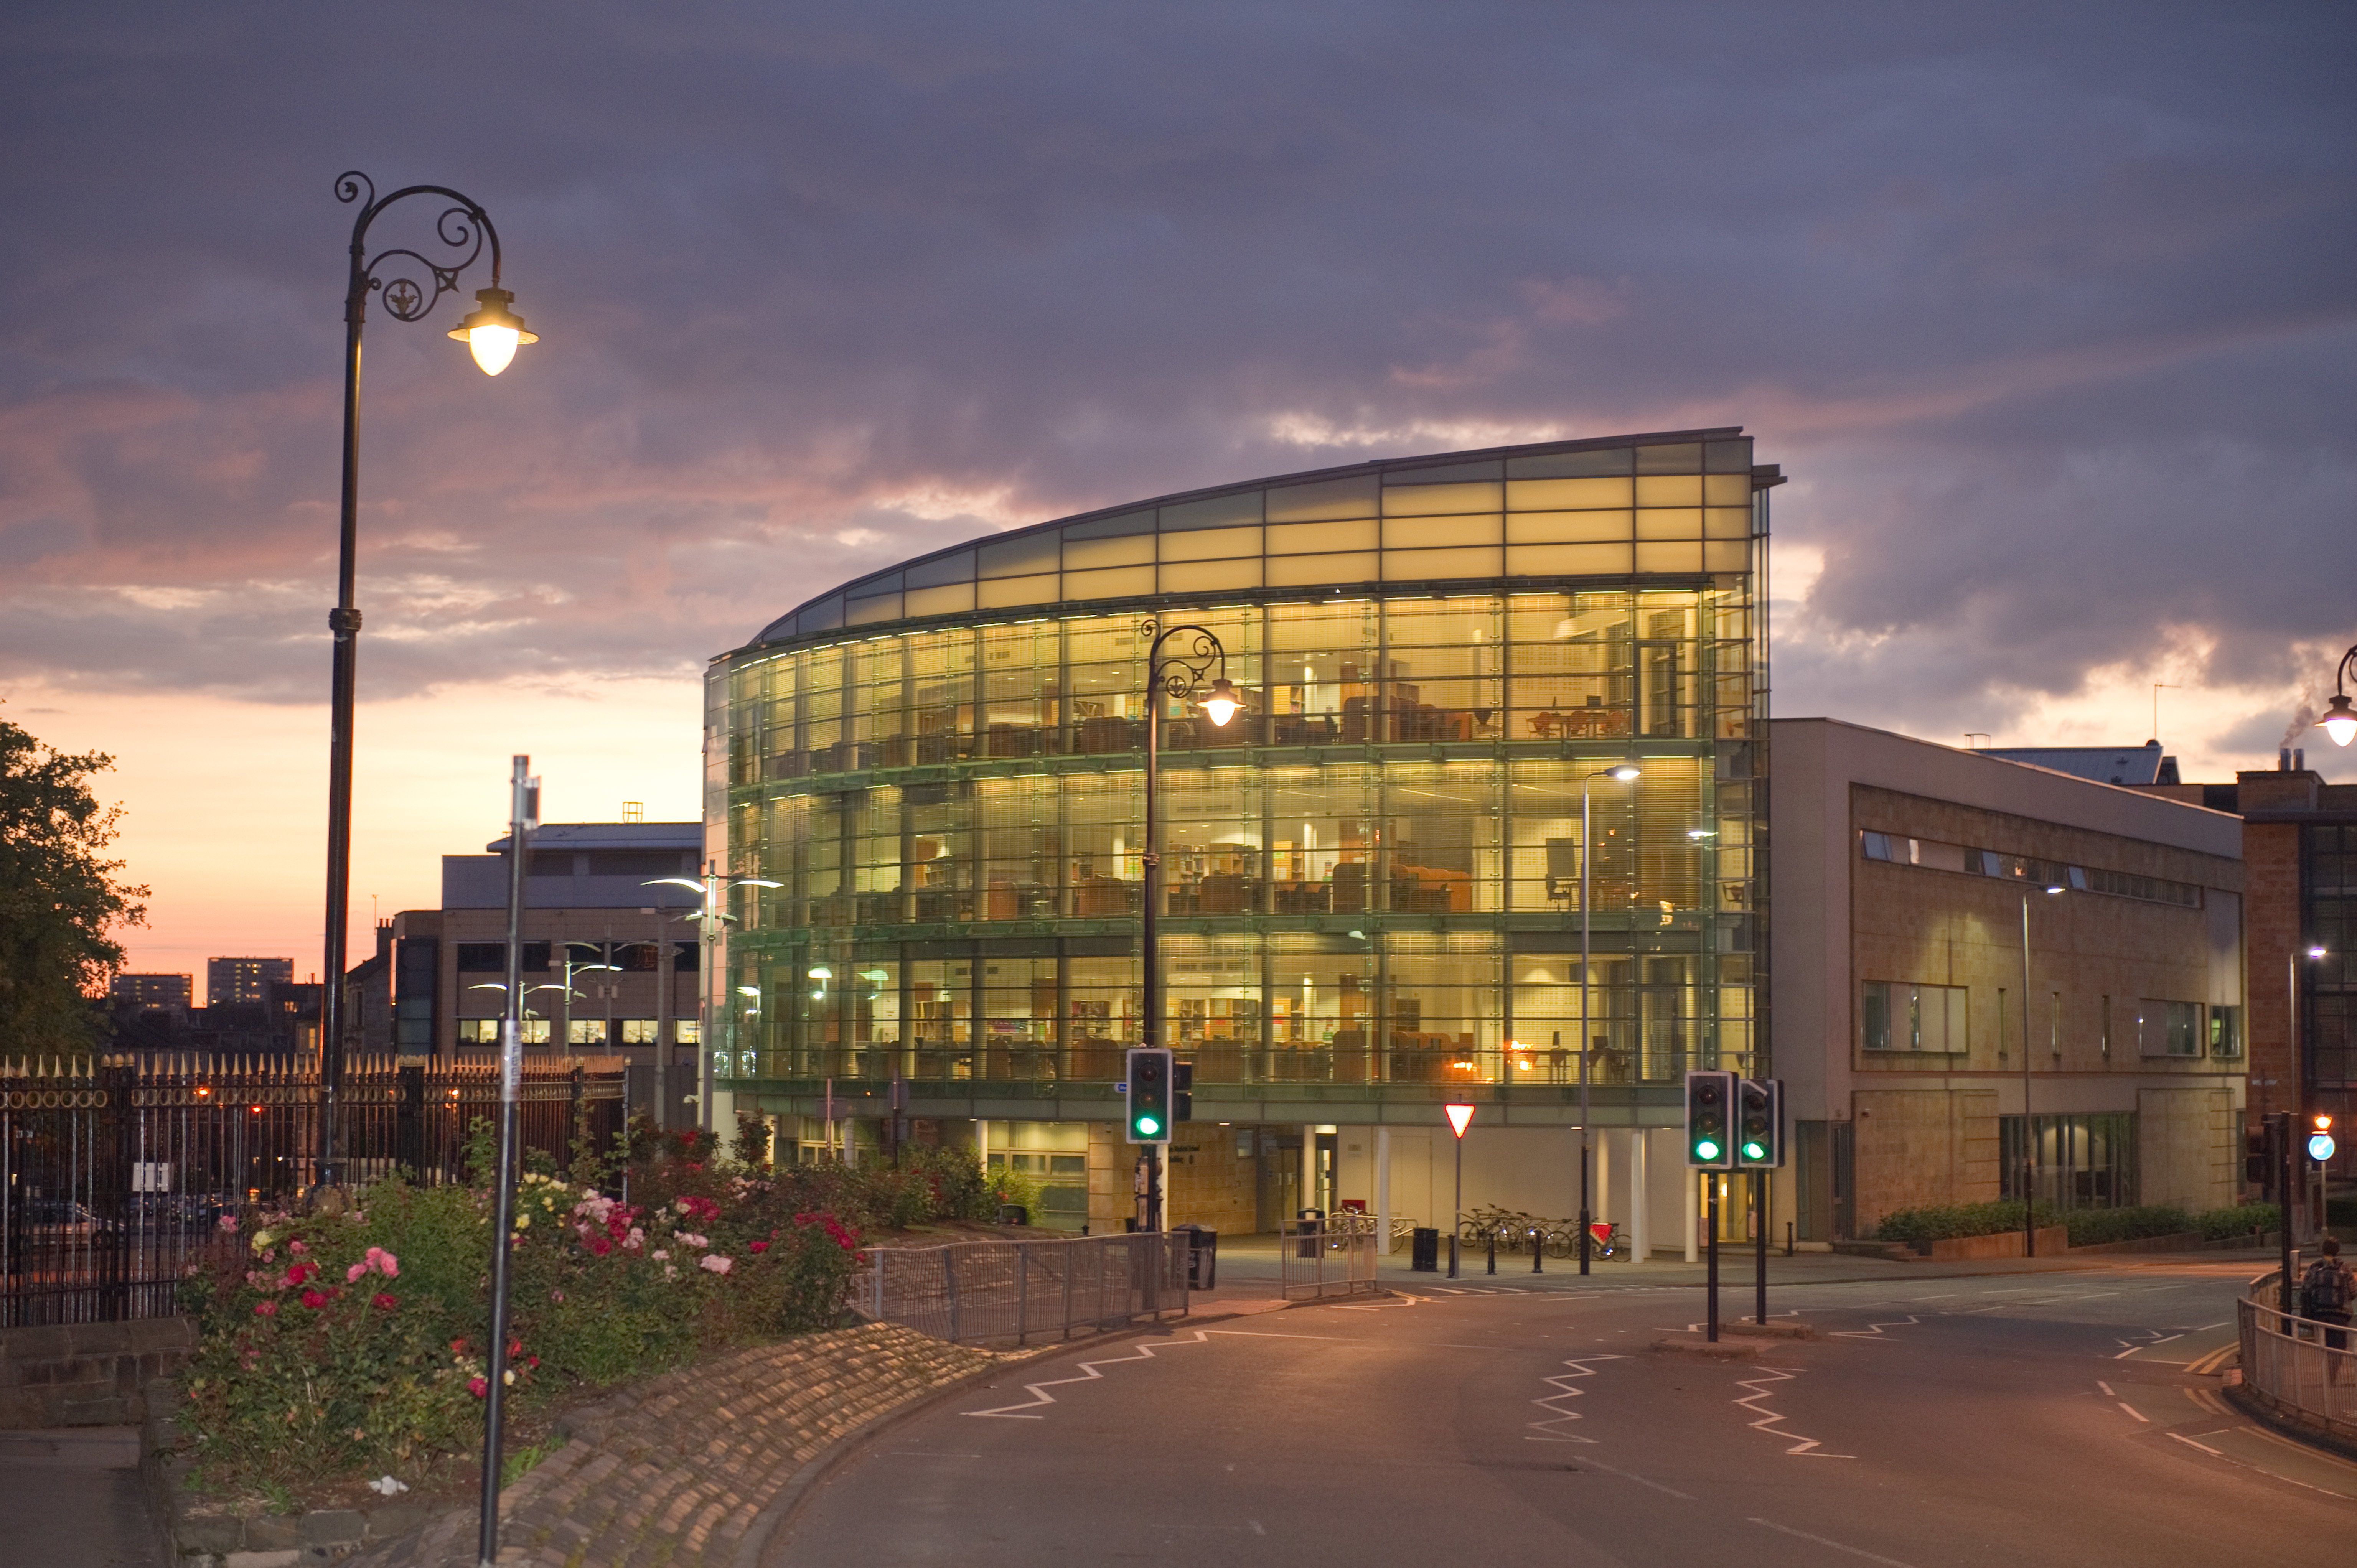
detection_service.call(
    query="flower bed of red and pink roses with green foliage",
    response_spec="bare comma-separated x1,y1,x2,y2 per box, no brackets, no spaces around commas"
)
166,1117,997,1509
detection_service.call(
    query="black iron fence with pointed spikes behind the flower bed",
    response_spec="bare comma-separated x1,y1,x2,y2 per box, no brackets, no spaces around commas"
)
0,1054,622,1328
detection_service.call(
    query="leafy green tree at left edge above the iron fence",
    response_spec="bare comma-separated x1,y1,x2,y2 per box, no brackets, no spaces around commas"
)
0,719,148,1052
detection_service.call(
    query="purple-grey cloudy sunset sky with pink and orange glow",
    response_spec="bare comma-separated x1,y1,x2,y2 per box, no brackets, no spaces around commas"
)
0,0,2357,990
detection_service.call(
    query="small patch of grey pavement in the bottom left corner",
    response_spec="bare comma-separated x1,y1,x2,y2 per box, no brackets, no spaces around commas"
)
0,1426,163,1568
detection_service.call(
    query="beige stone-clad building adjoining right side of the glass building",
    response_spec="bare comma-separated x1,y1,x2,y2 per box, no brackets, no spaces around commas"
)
1770,719,2248,1243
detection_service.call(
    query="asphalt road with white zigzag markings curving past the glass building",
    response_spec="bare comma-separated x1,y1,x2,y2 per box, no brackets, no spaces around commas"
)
768,1264,2357,1568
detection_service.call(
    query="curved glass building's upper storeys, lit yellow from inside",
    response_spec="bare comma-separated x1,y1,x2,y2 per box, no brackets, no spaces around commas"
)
707,429,1780,1226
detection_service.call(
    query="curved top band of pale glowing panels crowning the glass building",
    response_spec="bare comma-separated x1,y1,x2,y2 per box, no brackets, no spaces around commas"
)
726,425,1775,649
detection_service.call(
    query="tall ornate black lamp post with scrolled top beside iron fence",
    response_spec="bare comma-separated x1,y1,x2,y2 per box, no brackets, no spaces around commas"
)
318,170,540,1184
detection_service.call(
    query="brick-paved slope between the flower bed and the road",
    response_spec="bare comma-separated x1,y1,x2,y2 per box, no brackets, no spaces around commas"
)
346,1323,1009,1568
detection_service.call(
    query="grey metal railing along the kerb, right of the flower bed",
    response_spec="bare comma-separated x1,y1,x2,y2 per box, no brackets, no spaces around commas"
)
851,1231,1188,1344
